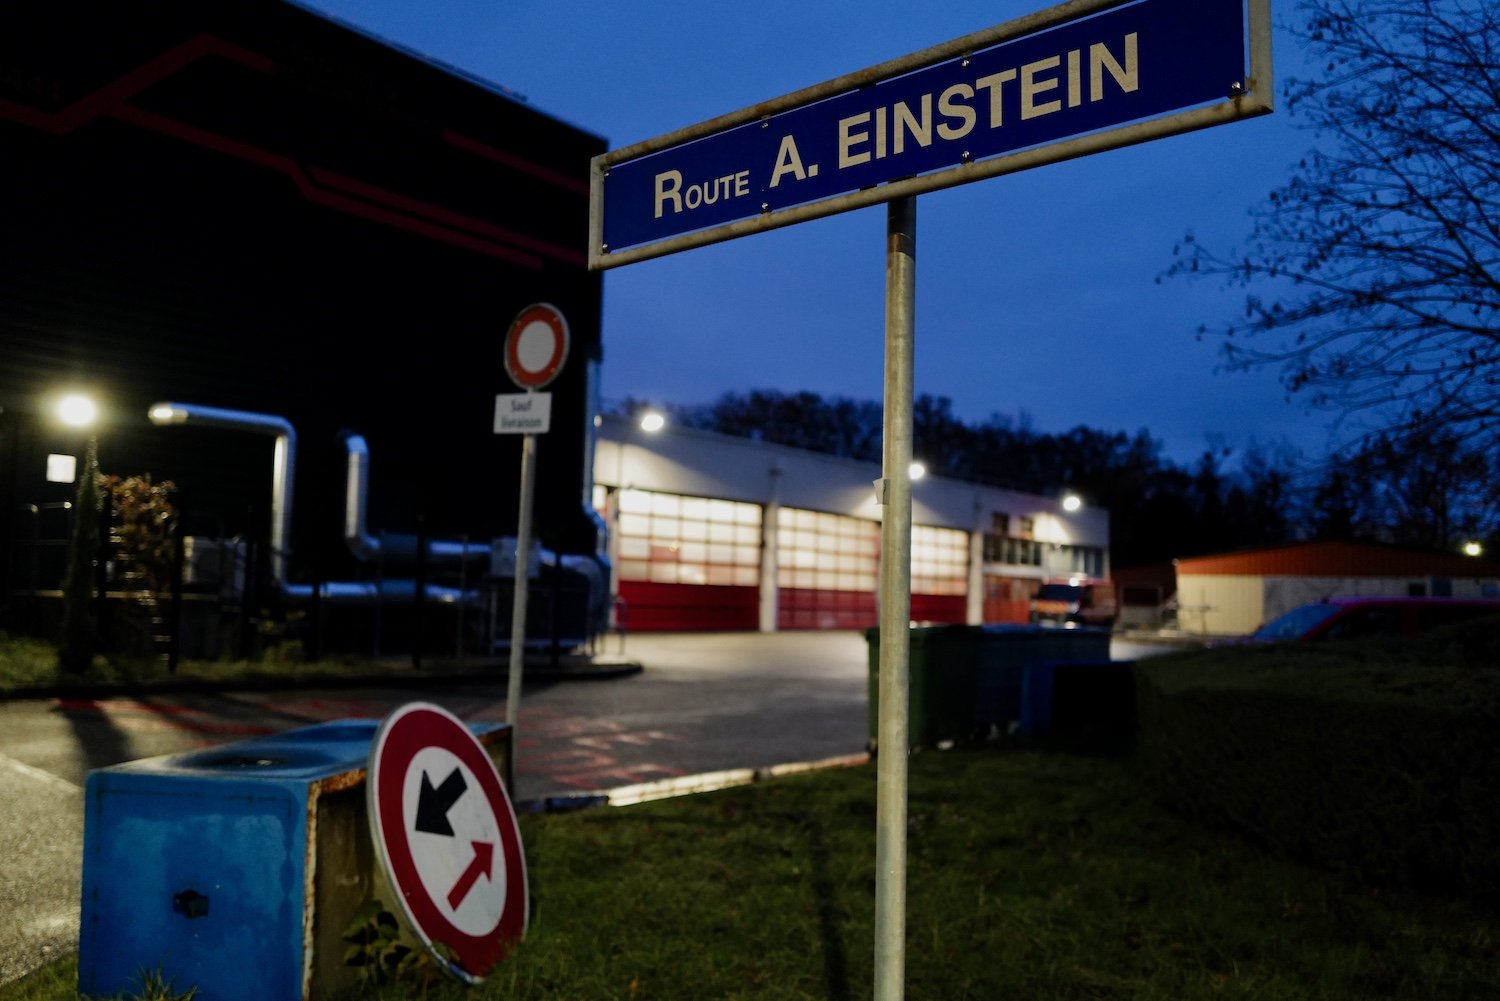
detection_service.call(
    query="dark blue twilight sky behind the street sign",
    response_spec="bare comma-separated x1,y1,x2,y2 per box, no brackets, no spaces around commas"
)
300,0,1334,465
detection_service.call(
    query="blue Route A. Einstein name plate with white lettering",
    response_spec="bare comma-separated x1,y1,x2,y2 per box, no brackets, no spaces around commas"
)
602,0,1247,254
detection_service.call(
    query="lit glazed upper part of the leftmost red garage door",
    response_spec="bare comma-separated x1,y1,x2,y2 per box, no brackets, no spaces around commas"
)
618,489,761,587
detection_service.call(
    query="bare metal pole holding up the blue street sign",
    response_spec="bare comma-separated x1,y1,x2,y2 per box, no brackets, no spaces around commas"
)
875,198,917,1001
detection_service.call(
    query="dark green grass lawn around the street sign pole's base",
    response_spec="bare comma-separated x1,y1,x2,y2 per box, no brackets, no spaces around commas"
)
0,744,1500,1001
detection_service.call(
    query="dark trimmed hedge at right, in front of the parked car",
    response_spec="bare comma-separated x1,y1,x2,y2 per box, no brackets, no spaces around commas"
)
1136,620,1500,896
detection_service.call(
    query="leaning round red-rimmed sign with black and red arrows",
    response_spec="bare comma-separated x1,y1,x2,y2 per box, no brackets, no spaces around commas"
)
366,702,528,983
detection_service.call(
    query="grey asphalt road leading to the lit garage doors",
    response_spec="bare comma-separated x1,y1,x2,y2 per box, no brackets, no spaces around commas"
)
0,632,1194,996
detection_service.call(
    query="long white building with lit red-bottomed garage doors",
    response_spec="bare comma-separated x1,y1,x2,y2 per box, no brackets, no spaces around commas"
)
593,416,1110,632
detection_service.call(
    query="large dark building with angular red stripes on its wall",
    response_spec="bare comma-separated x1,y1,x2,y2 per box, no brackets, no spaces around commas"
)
0,0,608,653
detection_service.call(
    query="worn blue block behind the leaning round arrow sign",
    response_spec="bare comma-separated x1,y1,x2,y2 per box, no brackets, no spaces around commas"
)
78,719,512,1001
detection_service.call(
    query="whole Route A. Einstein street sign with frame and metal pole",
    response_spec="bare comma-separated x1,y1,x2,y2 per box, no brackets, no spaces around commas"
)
588,0,1274,1001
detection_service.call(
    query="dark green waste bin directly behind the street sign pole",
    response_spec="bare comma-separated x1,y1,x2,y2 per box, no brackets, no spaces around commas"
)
864,626,984,749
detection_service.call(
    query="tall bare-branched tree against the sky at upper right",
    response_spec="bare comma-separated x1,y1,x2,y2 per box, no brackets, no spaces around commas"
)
1167,0,1500,441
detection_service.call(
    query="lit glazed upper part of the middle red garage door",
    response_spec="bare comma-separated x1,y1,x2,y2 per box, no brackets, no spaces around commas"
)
776,507,881,591
